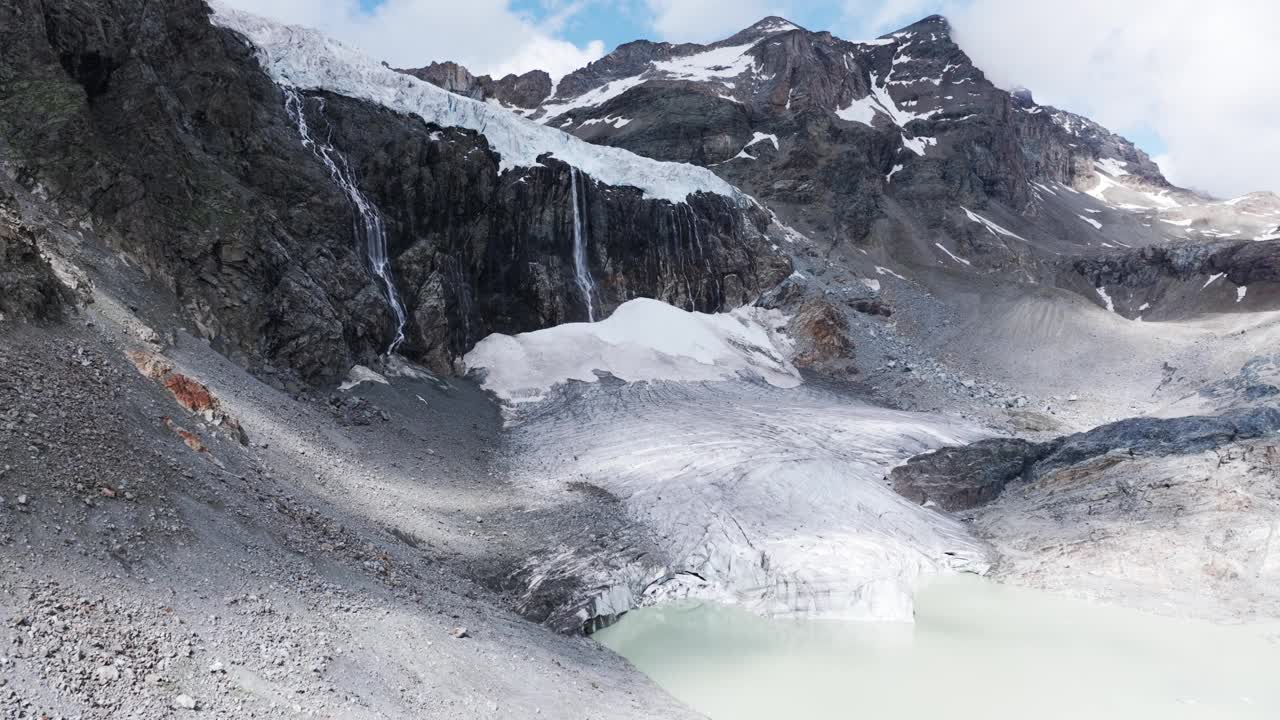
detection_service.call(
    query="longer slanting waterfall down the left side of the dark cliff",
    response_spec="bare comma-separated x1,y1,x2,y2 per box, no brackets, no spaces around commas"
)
284,88,408,355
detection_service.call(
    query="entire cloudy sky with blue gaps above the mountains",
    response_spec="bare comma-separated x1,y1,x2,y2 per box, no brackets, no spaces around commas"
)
223,0,1280,197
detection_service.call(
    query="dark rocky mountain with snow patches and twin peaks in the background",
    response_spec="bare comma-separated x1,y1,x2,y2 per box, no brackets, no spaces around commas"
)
419,15,1280,319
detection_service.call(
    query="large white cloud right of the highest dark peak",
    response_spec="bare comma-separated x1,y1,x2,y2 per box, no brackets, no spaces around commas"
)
948,0,1280,196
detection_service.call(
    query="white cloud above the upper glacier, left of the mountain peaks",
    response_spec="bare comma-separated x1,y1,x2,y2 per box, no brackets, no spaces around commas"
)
215,0,604,78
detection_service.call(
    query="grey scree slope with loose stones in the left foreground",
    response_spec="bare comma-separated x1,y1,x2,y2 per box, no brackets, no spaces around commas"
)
0,189,689,717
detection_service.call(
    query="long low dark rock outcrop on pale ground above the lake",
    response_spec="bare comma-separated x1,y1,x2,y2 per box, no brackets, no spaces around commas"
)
890,407,1280,510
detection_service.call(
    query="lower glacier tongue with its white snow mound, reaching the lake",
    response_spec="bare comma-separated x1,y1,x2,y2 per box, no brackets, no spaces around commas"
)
467,301,988,623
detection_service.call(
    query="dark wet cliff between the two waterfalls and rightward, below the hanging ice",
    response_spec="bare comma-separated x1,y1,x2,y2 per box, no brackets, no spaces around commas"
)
306,90,791,368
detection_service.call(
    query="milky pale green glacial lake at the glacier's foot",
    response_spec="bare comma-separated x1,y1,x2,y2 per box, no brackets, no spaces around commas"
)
594,577,1280,720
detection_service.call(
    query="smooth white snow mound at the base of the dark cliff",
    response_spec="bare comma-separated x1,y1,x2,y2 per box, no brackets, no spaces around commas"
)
466,299,800,401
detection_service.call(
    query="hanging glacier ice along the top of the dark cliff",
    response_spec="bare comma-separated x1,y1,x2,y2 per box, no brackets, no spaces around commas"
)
211,3,749,202
